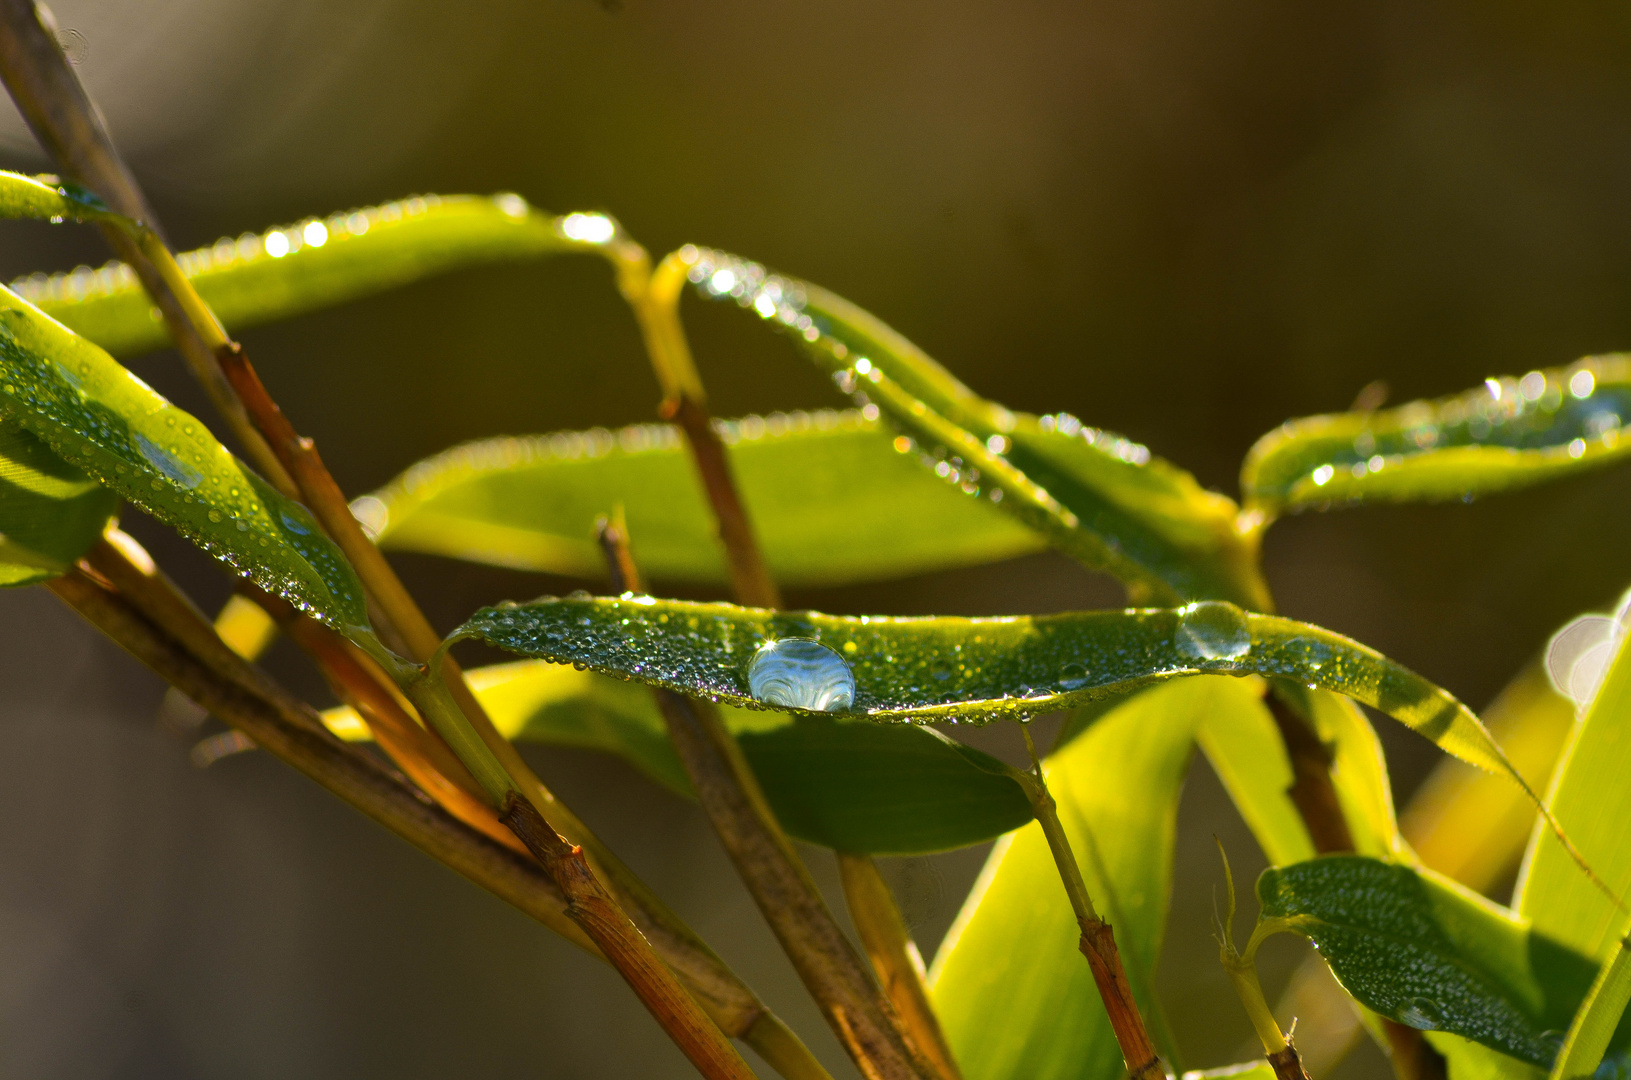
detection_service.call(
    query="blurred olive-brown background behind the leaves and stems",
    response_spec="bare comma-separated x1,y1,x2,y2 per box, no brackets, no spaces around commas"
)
0,0,1631,1080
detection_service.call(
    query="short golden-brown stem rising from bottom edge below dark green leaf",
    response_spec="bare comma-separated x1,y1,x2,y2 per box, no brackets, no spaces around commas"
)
838,852,962,1080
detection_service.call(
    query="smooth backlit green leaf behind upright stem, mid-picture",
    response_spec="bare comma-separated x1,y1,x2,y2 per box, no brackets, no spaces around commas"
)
356,409,1042,586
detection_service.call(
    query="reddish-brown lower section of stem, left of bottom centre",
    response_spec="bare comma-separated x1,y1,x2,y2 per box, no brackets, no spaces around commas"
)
499,791,754,1080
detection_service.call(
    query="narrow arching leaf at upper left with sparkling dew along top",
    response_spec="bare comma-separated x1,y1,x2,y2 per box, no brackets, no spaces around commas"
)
12,193,600,356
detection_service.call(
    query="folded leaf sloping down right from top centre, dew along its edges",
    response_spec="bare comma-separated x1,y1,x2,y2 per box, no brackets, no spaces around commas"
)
668,248,1269,609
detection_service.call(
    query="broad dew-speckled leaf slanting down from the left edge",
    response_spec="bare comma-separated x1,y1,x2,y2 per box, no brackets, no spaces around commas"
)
0,289,369,630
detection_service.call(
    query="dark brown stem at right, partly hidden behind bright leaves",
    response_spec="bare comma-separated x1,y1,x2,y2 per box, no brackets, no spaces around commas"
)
1266,688,1447,1080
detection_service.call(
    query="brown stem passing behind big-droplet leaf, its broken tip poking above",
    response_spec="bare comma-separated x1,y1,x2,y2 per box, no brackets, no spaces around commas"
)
599,520,936,1080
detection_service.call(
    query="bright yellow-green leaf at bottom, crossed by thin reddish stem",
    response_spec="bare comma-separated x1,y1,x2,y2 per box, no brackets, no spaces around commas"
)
930,679,1258,1080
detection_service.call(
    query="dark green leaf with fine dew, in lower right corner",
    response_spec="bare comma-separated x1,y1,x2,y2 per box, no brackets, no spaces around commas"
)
1258,855,1597,1067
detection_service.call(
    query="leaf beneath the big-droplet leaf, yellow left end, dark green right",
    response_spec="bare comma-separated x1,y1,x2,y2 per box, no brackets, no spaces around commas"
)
323,661,1031,855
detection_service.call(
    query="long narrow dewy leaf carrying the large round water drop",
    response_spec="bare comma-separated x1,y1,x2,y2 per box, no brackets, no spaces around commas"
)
453,597,1510,786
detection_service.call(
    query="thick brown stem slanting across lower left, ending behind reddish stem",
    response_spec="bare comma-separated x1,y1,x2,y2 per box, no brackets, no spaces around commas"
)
49,569,599,953
